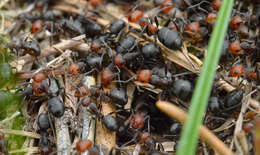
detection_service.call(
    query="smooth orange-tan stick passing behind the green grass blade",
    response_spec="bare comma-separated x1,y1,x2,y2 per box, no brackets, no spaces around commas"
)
156,101,234,155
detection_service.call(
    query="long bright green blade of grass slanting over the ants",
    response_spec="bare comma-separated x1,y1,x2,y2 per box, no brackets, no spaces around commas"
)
177,0,234,155
